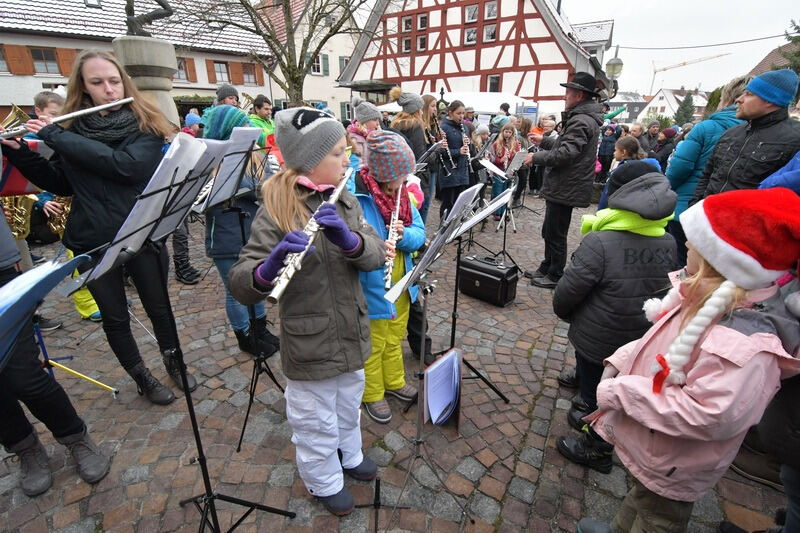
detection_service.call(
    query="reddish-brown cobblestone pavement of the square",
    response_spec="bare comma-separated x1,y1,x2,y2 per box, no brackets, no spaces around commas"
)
0,197,784,533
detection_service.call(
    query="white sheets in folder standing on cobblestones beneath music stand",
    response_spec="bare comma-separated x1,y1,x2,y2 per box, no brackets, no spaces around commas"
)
423,348,461,425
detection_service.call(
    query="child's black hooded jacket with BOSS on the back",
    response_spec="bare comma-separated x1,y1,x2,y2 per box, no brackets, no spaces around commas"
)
553,172,678,364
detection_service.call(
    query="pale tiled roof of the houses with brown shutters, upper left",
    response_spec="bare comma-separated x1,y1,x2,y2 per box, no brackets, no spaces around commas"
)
0,0,267,54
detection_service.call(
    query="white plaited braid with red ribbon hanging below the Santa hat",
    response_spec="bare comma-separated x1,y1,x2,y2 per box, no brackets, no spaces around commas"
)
652,280,736,385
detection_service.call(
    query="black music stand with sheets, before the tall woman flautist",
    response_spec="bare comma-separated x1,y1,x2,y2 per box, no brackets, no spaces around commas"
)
74,134,296,533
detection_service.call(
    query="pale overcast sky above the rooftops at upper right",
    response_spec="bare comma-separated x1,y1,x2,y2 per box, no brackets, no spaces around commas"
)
564,0,800,94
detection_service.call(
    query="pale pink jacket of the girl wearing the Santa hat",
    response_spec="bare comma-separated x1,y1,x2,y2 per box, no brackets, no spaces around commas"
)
587,276,800,502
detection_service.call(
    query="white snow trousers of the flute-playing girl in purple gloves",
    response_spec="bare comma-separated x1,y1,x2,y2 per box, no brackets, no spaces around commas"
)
284,369,364,497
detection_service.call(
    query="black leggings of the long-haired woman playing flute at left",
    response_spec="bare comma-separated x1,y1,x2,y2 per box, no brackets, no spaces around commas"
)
80,245,180,370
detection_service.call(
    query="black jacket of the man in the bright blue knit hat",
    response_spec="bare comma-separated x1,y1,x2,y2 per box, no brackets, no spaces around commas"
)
689,109,800,205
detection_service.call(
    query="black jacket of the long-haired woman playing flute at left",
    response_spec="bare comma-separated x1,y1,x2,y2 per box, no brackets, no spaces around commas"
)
3,124,164,255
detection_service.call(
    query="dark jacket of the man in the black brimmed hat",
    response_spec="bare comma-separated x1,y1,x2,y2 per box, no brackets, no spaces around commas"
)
532,100,603,207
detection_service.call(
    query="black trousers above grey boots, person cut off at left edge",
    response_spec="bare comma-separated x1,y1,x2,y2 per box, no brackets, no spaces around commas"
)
0,268,84,449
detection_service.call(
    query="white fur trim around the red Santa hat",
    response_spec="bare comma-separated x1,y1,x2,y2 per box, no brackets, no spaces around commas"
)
681,200,785,290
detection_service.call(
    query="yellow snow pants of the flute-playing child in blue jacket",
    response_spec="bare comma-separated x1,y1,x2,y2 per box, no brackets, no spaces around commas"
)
363,253,411,402
